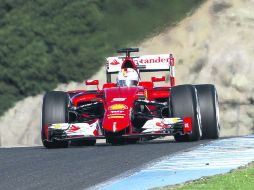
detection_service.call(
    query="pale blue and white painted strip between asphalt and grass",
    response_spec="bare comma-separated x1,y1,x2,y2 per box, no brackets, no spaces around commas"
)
96,135,254,190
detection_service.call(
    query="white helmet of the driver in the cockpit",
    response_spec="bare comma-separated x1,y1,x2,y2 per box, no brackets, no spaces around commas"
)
116,68,139,87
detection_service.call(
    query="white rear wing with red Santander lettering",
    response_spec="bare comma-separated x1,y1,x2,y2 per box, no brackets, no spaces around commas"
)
106,54,175,86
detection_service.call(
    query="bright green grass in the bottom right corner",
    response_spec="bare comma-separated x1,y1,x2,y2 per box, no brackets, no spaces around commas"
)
158,160,254,190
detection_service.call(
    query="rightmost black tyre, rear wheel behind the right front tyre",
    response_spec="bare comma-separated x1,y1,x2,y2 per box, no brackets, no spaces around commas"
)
195,84,220,139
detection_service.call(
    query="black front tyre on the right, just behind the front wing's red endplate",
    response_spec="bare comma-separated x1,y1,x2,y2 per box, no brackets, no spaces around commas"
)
169,85,202,142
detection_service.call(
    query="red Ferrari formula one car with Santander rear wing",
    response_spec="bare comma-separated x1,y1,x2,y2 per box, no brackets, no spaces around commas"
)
41,48,220,148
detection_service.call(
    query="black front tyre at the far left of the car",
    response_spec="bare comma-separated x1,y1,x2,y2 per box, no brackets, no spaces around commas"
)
41,91,69,148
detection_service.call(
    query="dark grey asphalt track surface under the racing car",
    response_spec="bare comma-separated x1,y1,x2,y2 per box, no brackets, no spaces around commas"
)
0,140,209,190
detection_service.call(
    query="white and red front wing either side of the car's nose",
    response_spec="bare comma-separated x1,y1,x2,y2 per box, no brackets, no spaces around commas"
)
47,117,192,141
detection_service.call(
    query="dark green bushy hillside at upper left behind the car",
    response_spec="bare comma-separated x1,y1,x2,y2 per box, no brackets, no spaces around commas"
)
0,0,204,115
